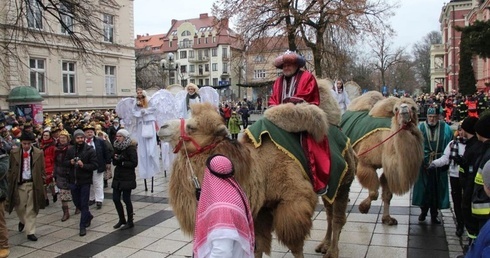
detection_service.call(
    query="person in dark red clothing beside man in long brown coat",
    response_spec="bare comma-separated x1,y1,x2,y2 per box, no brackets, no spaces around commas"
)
39,130,58,206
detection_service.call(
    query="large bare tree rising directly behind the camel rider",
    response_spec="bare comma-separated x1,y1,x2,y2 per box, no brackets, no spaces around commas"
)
213,0,394,77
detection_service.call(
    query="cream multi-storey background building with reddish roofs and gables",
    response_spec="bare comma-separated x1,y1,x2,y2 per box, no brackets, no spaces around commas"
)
135,13,243,100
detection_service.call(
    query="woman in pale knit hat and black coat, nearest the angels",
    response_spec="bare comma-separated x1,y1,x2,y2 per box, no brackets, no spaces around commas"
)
112,129,138,230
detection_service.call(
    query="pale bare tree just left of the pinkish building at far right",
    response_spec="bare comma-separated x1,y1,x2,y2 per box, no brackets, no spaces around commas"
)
412,31,442,92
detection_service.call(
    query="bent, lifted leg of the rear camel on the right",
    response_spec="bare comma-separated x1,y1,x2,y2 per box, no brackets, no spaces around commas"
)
356,163,379,213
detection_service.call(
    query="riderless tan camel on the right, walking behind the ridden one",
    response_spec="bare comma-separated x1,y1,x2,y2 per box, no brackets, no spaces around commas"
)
341,91,423,225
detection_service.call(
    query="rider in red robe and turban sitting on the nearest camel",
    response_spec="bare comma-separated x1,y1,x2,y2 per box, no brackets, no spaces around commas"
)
269,51,330,195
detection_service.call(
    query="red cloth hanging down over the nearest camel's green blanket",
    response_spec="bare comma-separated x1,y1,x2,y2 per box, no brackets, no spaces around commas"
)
301,133,330,193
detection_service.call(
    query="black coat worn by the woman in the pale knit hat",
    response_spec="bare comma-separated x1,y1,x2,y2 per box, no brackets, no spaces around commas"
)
112,143,138,190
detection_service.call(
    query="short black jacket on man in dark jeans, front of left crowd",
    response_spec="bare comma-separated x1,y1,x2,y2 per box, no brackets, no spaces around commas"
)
63,143,99,185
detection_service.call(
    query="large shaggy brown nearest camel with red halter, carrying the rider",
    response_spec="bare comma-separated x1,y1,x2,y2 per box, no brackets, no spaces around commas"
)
158,86,356,258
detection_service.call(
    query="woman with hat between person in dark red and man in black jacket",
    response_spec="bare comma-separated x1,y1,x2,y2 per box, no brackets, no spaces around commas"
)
54,130,76,221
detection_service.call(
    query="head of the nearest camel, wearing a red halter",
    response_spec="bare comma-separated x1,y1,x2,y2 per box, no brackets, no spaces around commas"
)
157,103,228,153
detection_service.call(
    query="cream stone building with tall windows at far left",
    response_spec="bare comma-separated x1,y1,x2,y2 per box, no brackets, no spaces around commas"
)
0,0,135,111
